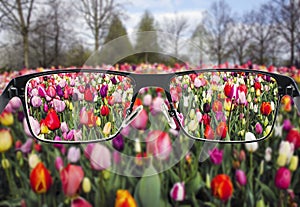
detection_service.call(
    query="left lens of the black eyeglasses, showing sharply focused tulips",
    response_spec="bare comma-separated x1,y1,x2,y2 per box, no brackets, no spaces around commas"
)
25,72,133,142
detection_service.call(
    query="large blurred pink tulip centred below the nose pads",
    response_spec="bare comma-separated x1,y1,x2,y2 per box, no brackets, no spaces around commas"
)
146,130,172,160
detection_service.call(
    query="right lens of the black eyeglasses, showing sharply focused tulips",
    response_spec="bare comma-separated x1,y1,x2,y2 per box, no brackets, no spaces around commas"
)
170,71,279,142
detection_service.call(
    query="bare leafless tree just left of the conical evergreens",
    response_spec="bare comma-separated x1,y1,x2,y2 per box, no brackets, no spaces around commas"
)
77,0,120,51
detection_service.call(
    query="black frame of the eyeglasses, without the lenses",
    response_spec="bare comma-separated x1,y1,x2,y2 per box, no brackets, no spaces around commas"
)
0,68,300,144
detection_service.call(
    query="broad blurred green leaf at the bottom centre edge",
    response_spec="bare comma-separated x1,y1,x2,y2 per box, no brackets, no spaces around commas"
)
134,165,161,207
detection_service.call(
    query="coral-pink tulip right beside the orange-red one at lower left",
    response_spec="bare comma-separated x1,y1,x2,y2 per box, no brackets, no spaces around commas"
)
60,164,84,197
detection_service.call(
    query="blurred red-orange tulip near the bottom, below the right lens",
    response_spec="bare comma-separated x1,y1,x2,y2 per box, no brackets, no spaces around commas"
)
211,174,233,201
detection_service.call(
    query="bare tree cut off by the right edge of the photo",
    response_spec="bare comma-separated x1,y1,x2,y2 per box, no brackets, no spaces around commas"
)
268,0,300,65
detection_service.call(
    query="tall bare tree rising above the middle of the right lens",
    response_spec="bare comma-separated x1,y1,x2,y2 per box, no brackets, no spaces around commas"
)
202,0,233,64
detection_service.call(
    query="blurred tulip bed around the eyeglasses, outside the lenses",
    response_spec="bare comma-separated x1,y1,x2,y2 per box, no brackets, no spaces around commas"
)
0,64,300,206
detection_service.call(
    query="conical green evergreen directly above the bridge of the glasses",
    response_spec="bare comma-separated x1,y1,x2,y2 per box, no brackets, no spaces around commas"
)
135,11,161,63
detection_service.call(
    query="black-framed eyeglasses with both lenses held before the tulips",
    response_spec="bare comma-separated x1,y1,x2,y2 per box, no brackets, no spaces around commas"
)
0,69,300,143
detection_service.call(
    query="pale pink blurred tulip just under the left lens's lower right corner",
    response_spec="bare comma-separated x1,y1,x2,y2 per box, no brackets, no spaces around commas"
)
89,143,111,170
